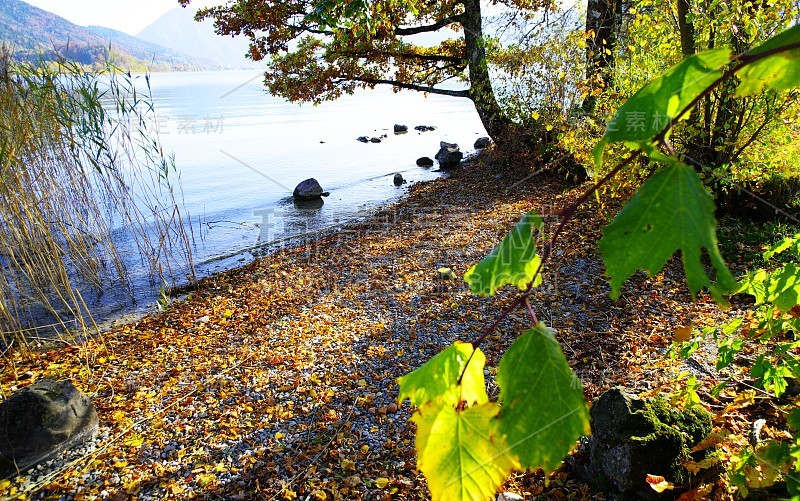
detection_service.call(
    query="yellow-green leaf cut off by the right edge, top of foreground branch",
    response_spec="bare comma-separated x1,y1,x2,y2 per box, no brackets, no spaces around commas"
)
736,25,800,97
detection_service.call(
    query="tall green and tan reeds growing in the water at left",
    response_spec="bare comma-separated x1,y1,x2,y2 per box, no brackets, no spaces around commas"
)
0,48,192,346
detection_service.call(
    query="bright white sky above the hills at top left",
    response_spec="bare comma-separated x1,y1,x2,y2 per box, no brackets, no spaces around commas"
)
25,0,214,35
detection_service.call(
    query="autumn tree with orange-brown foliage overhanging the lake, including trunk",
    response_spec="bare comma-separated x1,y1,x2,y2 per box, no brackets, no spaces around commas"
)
180,0,546,142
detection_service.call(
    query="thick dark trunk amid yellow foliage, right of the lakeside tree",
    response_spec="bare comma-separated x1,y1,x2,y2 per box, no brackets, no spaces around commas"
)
582,0,622,113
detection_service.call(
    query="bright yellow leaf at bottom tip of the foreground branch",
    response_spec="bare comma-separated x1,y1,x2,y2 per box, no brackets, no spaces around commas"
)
411,403,518,501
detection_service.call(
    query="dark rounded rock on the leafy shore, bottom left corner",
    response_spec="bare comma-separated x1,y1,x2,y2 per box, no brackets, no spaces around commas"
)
0,379,98,478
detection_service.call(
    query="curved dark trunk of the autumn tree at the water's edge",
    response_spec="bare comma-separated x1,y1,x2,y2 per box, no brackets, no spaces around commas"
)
462,0,513,144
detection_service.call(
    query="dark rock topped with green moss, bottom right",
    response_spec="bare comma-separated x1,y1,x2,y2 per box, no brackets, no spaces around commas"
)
576,388,711,499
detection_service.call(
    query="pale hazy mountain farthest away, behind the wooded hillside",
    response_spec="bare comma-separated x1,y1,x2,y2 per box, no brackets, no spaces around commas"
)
137,7,259,68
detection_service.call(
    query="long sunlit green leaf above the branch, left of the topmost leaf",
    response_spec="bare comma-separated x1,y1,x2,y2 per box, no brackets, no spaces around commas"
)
594,49,731,167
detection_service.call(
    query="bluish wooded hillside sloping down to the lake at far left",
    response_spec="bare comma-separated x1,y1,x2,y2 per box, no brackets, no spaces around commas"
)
0,0,218,70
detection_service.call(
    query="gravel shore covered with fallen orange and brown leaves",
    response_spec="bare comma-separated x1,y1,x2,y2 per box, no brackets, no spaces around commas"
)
0,160,736,500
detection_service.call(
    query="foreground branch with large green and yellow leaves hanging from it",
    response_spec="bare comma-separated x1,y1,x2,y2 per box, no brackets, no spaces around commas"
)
399,26,800,501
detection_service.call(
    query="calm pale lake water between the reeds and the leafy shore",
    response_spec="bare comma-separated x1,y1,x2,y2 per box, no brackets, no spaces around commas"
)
103,71,485,316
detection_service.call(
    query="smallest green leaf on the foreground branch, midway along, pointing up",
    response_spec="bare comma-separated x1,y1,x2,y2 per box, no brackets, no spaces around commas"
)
464,211,543,297
